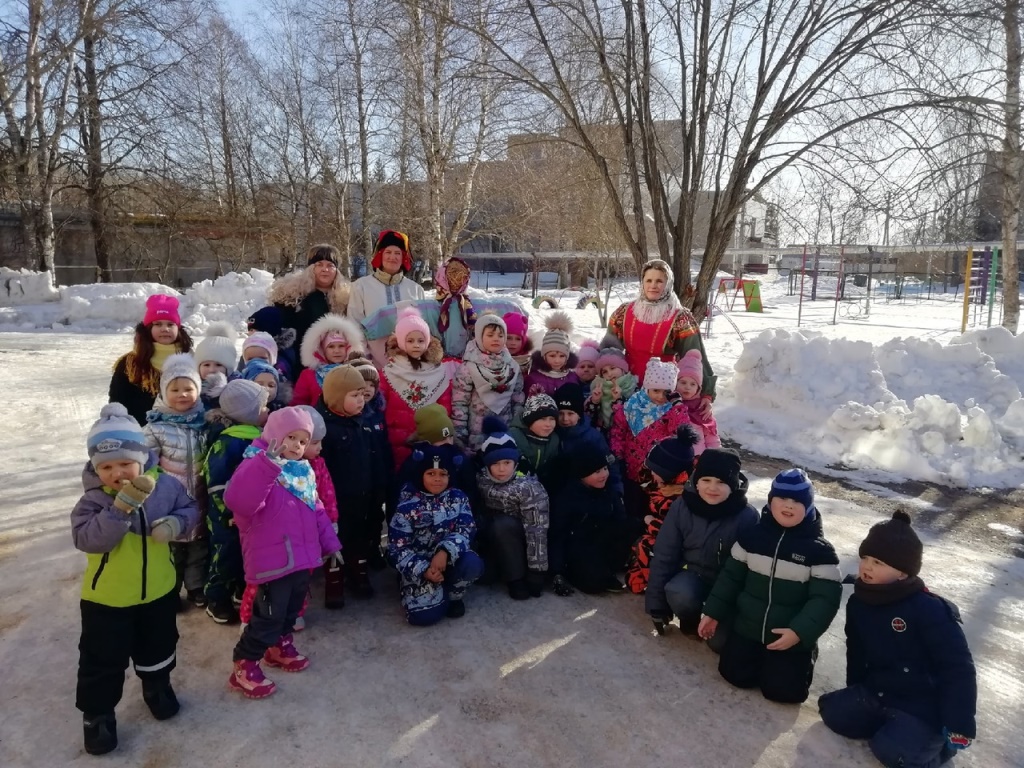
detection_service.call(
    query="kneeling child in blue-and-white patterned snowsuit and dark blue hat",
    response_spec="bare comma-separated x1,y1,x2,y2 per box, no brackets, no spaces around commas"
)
388,442,483,627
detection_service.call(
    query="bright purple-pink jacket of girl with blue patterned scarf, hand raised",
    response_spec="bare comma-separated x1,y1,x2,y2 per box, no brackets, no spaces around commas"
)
224,438,341,584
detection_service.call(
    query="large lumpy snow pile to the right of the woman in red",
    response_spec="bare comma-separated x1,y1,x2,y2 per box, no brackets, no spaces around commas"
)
716,331,1024,487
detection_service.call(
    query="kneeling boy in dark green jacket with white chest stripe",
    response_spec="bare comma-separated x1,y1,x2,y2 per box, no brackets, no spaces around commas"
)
700,466,843,703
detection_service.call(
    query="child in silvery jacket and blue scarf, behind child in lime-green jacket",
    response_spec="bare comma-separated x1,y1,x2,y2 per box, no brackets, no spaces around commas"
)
142,354,209,608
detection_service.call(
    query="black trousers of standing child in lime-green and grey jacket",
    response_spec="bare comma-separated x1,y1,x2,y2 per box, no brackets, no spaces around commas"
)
75,592,178,716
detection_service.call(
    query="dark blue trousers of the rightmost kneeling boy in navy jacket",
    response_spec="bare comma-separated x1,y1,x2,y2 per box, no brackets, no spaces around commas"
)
818,685,953,768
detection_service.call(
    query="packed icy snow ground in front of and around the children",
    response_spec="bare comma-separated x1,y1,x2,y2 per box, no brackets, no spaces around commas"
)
0,334,1024,768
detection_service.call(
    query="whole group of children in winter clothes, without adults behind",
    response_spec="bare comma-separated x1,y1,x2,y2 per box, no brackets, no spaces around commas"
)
73,297,975,766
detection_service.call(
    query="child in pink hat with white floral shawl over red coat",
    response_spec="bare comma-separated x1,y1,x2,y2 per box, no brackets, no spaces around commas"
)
380,307,459,468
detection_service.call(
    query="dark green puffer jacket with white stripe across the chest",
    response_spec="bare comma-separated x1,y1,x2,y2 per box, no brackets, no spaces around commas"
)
703,507,843,650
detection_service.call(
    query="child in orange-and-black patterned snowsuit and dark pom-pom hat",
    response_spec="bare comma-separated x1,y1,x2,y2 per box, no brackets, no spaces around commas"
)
626,424,697,595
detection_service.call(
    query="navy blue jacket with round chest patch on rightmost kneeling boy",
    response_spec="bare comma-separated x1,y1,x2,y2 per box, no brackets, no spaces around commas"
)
846,591,978,738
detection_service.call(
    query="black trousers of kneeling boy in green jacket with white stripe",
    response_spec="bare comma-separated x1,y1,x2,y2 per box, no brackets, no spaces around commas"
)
718,630,818,703
